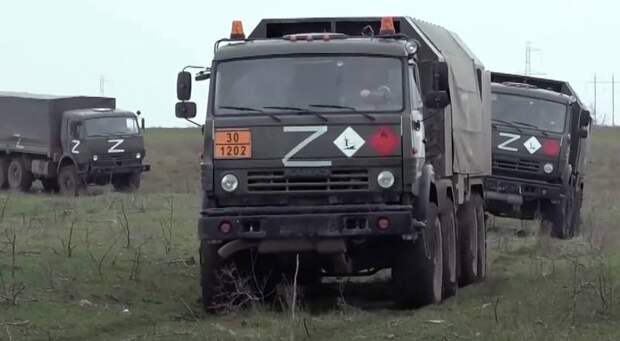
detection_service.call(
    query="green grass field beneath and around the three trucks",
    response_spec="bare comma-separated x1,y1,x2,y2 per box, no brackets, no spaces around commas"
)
0,129,620,340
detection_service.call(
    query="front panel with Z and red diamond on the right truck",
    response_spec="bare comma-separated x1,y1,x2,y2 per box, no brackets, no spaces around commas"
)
493,124,565,180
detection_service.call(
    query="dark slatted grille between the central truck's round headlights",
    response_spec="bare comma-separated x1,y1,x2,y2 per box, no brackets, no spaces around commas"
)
247,169,369,192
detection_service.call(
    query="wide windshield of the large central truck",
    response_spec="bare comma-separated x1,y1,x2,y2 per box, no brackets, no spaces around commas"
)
215,56,403,114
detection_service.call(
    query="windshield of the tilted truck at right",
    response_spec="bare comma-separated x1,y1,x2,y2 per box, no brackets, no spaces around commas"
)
493,93,567,133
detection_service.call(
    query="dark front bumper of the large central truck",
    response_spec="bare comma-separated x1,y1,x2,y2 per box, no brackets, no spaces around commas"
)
198,205,425,241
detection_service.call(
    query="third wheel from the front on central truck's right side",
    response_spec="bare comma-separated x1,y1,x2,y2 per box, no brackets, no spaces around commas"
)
457,194,478,286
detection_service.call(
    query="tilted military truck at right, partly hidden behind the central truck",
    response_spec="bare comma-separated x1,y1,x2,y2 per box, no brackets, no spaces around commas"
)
486,73,592,238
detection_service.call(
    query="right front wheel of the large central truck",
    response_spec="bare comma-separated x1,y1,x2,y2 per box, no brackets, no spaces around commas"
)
392,203,443,308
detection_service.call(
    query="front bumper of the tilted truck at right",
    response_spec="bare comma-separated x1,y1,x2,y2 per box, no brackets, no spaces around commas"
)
484,176,567,205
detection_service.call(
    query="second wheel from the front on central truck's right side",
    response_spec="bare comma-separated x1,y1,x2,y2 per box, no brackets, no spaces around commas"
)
439,200,458,297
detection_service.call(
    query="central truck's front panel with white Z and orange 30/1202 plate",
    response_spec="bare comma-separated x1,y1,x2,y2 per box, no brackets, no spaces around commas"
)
213,113,402,168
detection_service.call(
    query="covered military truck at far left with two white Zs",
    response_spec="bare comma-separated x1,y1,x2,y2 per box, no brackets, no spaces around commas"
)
0,92,150,195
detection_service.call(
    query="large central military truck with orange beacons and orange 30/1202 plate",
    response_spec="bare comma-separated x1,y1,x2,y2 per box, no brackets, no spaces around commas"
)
175,17,491,311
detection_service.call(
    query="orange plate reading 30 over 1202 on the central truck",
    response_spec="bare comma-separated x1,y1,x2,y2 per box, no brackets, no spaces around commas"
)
214,129,252,159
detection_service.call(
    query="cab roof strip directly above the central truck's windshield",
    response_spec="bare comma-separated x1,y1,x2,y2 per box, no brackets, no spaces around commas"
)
214,37,407,61
